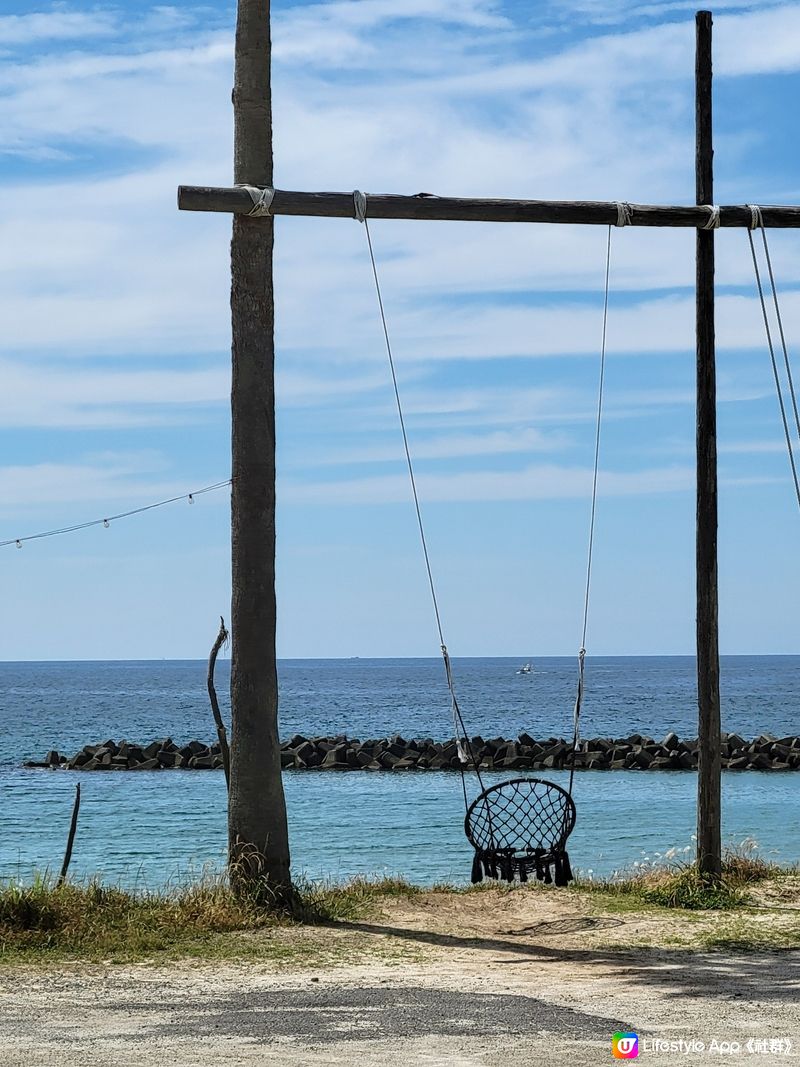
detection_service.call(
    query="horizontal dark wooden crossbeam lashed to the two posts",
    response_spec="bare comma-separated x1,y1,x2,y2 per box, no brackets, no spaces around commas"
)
178,186,800,229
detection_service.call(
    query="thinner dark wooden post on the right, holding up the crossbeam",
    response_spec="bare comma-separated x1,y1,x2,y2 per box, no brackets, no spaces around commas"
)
695,11,722,879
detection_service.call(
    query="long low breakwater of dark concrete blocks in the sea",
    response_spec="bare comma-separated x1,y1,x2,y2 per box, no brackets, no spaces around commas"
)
25,733,800,771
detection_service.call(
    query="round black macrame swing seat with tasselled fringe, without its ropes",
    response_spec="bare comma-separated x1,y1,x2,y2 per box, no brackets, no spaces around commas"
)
464,778,576,886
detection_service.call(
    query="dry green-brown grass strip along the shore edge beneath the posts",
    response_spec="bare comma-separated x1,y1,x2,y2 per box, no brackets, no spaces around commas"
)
0,848,800,967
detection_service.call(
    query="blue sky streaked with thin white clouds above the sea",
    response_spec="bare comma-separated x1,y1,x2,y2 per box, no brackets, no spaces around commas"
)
0,0,800,659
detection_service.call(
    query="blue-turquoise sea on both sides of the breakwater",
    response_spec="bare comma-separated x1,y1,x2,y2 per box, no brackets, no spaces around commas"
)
0,656,800,888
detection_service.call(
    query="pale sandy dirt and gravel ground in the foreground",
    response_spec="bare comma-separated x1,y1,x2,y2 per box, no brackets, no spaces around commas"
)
0,890,800,1067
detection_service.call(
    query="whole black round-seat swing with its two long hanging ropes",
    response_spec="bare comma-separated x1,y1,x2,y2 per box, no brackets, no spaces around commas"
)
353,191,614,886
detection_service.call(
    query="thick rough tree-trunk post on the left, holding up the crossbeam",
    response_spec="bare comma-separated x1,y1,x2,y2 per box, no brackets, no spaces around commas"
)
228,0,291,902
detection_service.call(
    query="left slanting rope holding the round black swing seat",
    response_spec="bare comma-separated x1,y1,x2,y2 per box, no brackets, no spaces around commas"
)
353,190,484,809
